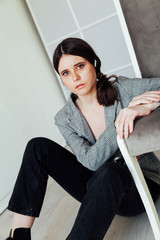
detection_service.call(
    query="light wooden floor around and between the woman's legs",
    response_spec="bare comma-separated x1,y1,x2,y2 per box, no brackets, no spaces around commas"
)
0,151,160,240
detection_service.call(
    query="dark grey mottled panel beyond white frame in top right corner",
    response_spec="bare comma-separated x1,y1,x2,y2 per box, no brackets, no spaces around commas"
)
120,0,160,77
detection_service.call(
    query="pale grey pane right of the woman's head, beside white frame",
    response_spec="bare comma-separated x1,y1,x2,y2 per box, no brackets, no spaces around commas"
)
83,16,131,72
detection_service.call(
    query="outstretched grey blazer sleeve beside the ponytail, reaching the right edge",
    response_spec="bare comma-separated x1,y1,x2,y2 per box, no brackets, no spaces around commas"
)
118,76,160,100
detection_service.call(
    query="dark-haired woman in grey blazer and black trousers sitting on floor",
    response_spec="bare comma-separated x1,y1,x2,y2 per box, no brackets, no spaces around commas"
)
5,38,160,240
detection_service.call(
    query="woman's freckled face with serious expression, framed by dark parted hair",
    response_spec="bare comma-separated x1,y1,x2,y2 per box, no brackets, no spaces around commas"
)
58,54,96,96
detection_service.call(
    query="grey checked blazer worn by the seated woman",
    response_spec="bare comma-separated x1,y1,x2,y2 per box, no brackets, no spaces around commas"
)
55,76,160,184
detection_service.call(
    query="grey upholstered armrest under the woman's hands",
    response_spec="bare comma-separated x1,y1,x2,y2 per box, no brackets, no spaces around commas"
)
126,109,160,156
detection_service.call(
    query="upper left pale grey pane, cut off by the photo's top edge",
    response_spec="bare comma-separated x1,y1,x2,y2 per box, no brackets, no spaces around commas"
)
28,0,76,43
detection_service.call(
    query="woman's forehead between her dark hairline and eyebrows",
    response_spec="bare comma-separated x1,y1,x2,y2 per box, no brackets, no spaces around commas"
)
58,54,88,72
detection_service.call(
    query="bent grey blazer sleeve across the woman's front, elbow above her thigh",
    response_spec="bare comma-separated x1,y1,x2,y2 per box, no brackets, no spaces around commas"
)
55,116,118,171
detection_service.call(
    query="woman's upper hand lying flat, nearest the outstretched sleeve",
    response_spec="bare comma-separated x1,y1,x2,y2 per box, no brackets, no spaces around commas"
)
128,91,160,107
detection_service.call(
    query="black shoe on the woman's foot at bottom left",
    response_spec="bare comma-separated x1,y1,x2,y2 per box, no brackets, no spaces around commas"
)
6,228,31,240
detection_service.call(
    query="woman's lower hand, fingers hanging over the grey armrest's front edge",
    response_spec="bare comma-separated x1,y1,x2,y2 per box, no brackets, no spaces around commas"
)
115,104,153,138
